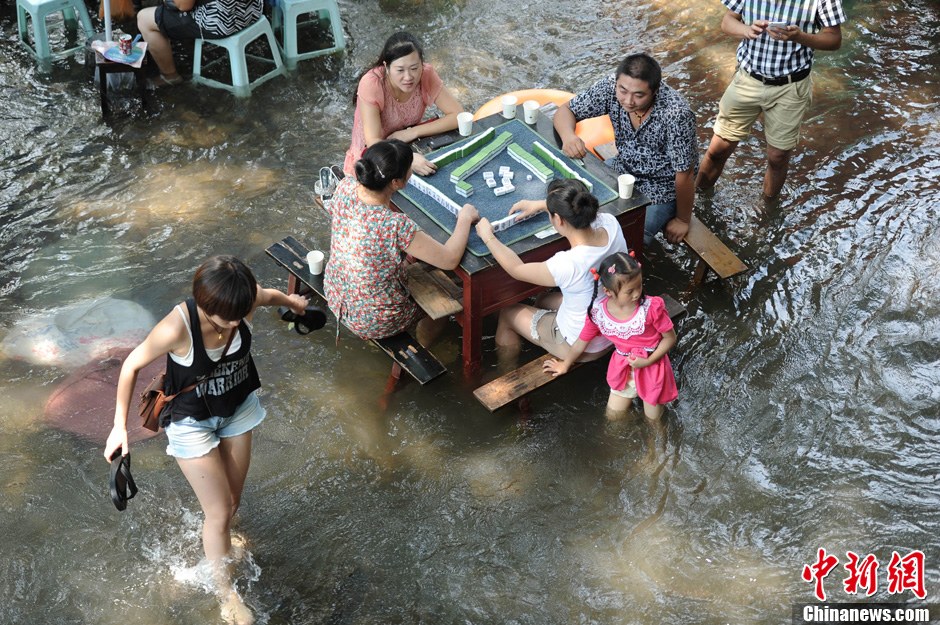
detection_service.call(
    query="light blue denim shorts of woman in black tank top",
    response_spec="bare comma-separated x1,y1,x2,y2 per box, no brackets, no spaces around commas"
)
166,392,267,458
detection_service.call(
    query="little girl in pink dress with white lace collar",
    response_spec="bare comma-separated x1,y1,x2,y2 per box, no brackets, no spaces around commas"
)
545,252,679,420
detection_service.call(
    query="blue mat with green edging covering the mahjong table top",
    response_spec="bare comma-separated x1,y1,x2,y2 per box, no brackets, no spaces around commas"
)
401,119,617,256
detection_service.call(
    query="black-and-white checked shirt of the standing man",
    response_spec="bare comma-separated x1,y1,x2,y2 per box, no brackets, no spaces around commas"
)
721,0,845,78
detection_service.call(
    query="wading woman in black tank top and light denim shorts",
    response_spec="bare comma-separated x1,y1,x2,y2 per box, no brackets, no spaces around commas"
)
104,256,307,624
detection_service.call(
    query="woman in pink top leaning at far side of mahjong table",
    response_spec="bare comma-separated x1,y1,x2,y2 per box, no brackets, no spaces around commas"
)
343,32,463,176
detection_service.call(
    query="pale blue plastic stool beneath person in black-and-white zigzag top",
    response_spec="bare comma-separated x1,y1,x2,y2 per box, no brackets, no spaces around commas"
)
193,16,284,98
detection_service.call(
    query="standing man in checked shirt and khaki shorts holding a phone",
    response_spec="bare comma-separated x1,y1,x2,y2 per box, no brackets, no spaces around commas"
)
695,0,845,198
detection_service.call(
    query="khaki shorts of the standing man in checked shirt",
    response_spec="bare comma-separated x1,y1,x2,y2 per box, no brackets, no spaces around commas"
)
715,68,813,150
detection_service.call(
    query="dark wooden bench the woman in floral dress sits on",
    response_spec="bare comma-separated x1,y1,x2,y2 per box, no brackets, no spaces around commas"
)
265,236,447,384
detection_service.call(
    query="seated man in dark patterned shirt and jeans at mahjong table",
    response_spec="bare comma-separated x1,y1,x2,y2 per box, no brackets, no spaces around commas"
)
554,54,698,243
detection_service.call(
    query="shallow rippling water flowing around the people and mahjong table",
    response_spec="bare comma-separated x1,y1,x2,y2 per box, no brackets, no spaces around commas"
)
0,0,940,625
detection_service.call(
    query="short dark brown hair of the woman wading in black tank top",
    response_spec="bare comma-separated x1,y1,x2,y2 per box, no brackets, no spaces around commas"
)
193,255,258,321
